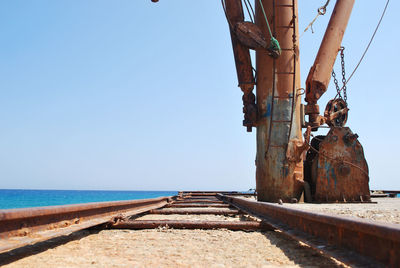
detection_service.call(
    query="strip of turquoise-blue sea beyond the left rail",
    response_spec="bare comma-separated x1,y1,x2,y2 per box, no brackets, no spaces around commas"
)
0,189,178,209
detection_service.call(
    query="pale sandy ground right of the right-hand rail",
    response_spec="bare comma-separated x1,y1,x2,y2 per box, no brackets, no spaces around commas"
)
283,198,400,224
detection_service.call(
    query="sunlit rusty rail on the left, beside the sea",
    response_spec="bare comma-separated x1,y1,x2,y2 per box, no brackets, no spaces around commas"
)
0,197,172,253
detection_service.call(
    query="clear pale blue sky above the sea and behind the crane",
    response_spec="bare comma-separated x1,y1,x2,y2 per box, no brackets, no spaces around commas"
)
0,0,400,190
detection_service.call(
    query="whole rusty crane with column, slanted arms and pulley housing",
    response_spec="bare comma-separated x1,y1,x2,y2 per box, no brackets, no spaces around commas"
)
222,0,370,202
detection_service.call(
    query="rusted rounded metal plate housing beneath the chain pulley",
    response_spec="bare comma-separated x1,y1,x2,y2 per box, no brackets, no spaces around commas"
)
305,127,371,202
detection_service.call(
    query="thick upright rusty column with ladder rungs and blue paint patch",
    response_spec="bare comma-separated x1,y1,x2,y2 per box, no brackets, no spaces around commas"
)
255,0,303,202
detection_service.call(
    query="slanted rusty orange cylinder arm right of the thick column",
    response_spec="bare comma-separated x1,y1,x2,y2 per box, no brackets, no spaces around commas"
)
306,0,355,127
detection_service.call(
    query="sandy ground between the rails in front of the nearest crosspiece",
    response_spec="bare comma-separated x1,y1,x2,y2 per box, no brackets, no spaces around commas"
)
4,229,346,267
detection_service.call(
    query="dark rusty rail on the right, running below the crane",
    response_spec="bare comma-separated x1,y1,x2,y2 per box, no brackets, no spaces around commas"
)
220,195,400,267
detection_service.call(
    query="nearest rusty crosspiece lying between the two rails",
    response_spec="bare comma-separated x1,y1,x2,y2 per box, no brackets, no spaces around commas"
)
109,220,273,231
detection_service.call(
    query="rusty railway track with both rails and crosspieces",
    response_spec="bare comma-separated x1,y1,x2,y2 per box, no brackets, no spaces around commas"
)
0,192,400,267
